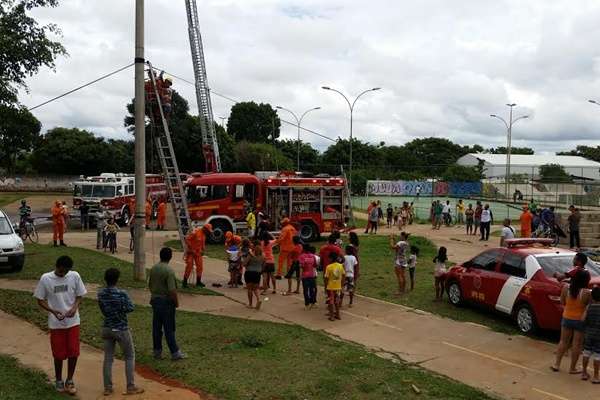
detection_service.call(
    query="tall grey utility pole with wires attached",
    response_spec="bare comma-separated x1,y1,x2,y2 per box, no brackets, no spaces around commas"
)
133,0,146,281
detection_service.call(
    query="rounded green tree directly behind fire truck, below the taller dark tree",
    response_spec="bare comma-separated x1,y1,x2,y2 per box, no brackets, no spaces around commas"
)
234,141,294,172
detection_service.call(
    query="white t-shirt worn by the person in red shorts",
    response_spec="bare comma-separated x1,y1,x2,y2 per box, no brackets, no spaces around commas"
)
33,271,87,329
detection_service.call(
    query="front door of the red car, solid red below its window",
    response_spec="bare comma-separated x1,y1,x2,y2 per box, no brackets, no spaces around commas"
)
463,249,501,304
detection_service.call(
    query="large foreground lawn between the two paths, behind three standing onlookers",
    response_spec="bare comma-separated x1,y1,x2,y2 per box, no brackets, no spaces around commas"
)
0,290,490,400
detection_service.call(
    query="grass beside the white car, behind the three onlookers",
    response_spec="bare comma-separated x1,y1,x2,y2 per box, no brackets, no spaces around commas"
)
0,243,220,296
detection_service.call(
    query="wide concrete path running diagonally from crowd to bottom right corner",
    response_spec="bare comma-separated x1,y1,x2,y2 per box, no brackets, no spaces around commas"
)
24,228,600,400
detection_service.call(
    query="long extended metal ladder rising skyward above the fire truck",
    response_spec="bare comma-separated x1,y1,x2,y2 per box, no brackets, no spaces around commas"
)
185,0,221,172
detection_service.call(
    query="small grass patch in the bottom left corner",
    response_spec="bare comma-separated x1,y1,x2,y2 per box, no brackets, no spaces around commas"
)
0,355,67,400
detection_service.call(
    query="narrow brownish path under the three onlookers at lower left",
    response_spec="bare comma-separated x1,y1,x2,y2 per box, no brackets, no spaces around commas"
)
0,311,207,400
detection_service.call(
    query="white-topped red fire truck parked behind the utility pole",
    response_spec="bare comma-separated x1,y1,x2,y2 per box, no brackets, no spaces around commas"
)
73,173,168,223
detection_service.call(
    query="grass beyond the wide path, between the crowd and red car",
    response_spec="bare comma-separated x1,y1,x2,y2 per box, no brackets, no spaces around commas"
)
165,235,519,334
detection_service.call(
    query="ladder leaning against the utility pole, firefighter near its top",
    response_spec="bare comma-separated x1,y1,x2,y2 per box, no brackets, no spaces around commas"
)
147,61,190,249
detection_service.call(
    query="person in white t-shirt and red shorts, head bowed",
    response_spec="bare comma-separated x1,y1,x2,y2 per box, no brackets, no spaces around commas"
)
33,256,87,395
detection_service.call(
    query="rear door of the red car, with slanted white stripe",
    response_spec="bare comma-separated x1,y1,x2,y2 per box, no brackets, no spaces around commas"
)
495,251,531,314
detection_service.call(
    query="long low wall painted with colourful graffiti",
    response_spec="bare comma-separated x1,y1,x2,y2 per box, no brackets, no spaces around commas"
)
367,181,482,197
